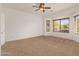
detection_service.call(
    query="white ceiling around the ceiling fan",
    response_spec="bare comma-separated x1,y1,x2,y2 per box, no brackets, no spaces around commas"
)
2,3,79,13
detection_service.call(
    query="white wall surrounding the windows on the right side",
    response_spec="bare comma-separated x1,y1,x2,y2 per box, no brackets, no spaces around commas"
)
45,7,79,42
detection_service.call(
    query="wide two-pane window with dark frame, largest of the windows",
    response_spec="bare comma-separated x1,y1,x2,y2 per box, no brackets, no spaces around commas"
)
53,18,69,33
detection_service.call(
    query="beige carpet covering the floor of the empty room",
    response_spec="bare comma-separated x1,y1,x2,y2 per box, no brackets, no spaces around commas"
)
1,36,79,56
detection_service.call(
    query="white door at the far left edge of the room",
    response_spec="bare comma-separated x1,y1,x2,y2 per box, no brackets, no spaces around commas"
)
0,14,5,45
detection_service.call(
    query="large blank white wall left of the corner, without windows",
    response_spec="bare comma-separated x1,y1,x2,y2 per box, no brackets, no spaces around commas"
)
4,8,43,41
